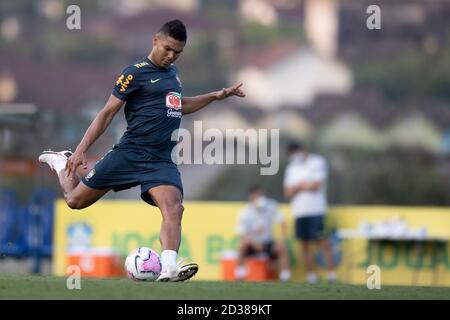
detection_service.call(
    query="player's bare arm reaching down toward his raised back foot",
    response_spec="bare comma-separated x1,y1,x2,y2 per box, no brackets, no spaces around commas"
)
66,95,125,176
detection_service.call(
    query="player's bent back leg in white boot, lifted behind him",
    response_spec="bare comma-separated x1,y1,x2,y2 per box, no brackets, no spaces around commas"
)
39,150,109,209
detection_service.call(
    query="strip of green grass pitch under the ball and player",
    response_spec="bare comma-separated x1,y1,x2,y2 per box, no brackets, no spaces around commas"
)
0,274,450,300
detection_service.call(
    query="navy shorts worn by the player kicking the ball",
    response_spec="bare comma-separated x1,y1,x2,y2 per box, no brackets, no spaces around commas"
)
81,147,183,206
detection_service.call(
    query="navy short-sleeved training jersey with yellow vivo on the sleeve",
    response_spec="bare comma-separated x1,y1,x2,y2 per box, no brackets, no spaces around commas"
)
112,57,182,161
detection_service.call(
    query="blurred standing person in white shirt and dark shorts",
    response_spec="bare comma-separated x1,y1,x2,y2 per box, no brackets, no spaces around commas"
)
283,143,336,283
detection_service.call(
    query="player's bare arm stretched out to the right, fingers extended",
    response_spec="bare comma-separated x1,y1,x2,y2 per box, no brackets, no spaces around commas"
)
182,83,245,114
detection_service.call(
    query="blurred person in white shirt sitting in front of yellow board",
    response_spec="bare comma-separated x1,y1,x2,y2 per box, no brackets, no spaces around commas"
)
236,186,291,281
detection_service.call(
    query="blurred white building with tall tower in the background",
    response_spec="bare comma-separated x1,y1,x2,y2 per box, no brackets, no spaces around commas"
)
237,0,353,110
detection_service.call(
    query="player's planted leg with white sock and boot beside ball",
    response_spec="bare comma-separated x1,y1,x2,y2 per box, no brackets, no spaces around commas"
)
148,185,198,281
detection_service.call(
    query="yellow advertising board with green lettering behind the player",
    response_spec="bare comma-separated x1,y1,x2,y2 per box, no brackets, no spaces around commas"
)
53,200,450,286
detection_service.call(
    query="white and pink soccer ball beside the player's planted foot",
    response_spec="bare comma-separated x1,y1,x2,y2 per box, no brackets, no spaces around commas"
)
125,247,161,281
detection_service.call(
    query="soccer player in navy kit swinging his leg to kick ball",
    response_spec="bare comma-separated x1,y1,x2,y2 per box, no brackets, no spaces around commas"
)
39,20,245,281
